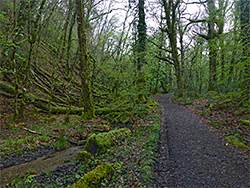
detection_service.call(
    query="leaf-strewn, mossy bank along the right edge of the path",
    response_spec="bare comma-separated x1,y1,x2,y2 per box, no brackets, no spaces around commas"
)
173,91,250,150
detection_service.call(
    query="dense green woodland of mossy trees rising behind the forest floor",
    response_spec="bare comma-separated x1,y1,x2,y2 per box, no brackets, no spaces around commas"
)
0,0,250,117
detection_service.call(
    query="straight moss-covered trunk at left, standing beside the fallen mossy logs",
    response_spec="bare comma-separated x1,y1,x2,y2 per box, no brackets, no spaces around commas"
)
76,0,94,119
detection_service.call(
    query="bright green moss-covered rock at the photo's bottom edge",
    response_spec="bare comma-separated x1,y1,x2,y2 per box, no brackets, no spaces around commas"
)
70,163,115,188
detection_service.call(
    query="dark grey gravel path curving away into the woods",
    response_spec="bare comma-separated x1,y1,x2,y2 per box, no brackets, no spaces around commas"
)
153,95,250,188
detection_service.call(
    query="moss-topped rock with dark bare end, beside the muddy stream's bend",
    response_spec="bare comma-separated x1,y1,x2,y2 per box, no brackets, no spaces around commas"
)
85,128,131,155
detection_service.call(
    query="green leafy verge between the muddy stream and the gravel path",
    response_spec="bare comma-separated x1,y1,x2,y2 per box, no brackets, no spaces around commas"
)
3,102,161,188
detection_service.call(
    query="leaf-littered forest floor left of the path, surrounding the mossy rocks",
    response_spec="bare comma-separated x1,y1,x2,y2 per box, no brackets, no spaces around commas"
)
0,97,161,188
